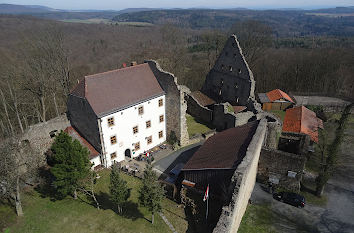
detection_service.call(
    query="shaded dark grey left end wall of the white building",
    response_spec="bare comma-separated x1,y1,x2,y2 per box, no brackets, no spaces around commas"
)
67,95,102,153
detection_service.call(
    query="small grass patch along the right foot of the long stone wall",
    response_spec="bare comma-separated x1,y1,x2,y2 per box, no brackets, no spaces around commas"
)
238,204,276,233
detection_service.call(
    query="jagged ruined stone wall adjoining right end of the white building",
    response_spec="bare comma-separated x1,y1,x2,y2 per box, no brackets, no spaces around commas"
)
146,61,190,146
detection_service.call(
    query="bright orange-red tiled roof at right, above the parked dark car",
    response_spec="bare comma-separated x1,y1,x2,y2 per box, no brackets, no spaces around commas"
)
283,106,323,143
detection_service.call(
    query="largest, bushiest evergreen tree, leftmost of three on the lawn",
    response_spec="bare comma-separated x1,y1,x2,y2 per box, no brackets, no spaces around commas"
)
50,131,90,199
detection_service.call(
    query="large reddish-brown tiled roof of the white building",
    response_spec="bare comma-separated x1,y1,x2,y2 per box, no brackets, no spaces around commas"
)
71,63,164,116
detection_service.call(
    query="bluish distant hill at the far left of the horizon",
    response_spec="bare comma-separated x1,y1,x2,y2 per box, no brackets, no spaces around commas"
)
0,4,56,14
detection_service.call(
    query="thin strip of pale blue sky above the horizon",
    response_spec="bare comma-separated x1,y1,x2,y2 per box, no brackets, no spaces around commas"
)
0,0,354,10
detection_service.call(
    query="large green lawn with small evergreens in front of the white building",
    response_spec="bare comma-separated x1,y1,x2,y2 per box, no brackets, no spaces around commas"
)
0,170,188,233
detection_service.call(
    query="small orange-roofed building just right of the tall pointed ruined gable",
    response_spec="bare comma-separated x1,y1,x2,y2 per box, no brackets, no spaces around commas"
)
258,89,295,111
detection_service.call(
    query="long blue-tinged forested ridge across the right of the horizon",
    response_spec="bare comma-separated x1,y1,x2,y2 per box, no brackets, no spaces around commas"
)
113,8,354,37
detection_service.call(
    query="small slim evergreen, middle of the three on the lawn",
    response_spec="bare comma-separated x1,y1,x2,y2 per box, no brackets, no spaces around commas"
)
109,166,130,214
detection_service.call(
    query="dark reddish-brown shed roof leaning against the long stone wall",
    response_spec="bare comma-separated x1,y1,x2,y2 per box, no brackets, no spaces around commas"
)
182,121,258,170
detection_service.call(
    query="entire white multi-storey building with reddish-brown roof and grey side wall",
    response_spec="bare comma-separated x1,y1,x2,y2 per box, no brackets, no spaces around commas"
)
68,64,166,167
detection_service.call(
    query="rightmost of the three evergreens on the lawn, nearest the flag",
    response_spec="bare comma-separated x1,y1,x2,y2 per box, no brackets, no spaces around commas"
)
139,166,164,224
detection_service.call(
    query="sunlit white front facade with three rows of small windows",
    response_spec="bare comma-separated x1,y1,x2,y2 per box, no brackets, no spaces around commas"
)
99,95,166,167
